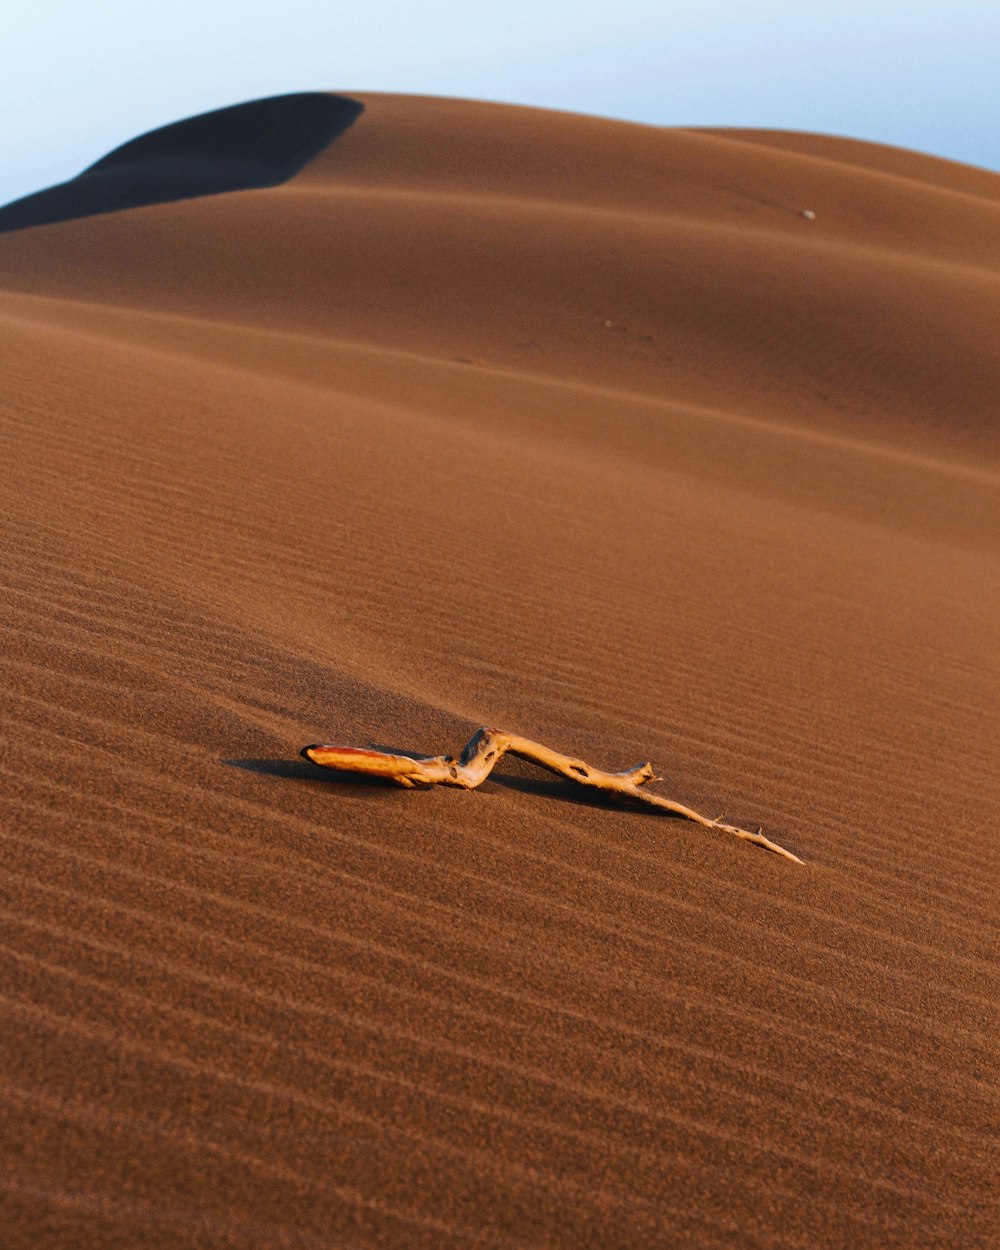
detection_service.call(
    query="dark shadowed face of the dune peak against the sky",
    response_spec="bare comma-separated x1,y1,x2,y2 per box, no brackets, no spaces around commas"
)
0,91,365,233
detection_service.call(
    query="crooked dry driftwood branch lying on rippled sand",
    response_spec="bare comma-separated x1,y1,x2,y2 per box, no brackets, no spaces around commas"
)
300,729,803,864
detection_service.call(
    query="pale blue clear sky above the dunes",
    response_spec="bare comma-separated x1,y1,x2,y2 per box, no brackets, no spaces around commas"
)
0,0,1000,204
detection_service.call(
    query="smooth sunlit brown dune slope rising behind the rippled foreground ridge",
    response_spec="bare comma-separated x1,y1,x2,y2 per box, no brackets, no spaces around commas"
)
0,96,1000,459
